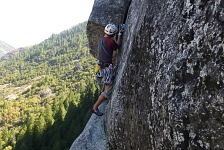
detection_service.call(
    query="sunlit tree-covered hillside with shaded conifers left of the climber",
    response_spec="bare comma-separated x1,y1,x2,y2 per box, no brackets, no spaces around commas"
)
0,22,99,150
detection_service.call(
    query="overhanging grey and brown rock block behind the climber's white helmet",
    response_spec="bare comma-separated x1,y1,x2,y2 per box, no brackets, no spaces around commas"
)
86,0,131,57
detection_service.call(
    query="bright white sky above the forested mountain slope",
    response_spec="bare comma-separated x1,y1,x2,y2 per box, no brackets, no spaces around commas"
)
0,0,94,48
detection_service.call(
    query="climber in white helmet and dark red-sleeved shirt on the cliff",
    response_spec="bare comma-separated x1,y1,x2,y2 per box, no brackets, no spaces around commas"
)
92,24,123,116
